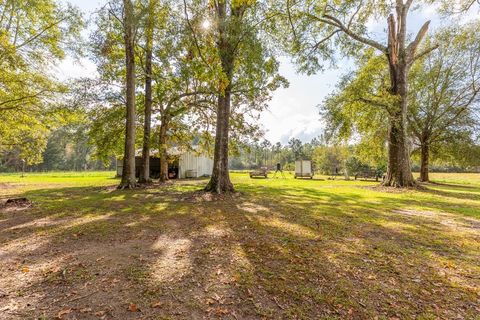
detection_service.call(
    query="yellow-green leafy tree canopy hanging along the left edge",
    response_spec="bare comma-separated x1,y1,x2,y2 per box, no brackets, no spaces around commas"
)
0,0,83,164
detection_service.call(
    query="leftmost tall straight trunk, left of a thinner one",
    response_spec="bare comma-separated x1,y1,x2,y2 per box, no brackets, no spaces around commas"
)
118,0,136,189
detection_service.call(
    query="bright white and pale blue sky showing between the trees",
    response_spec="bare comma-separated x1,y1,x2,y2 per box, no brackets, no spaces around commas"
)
57,0,474,144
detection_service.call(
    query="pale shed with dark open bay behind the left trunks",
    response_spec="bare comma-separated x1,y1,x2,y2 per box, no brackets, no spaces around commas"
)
117,148,213,179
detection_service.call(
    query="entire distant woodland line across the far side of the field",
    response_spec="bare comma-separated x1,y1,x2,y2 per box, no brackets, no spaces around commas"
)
0,124,480,179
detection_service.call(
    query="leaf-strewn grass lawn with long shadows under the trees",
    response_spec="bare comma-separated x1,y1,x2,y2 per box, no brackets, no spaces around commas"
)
0,172,480,319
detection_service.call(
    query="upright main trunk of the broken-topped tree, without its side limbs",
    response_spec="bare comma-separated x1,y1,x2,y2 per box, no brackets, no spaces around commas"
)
383,10,415,188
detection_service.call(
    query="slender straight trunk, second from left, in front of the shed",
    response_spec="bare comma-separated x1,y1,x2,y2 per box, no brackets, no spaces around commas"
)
138,1,153,183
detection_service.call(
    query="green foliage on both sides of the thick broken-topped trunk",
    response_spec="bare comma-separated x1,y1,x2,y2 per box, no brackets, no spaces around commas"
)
321,23,480,180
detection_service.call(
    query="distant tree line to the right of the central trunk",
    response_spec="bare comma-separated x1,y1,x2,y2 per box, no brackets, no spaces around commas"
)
230,136,480,177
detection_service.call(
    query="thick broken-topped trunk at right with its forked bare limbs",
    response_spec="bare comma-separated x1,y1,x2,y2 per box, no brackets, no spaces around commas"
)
319,0,436,187
